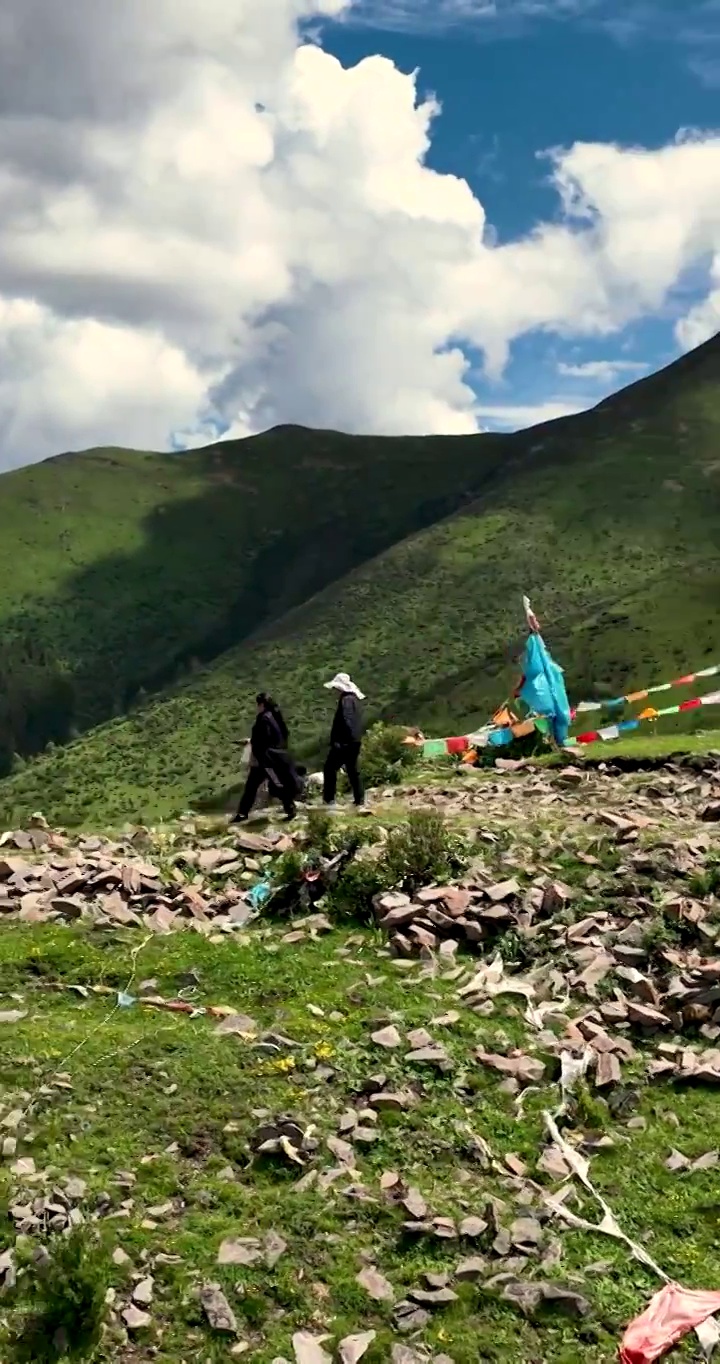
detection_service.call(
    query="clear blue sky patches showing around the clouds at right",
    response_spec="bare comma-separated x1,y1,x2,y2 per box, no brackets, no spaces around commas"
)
313,0,720,427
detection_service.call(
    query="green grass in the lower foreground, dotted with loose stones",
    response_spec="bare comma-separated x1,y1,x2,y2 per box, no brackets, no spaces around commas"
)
0,929,720,1364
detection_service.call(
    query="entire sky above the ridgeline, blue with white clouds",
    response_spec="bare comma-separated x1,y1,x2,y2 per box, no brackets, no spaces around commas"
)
0,0,720,469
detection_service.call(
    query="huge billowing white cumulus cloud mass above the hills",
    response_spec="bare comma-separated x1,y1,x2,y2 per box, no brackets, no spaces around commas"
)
0,0,720,468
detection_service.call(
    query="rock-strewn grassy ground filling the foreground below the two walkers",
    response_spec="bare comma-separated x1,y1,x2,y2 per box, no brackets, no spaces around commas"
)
0,756,720,1364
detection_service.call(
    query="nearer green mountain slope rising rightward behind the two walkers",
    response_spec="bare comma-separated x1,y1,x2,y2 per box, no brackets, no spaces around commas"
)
0,338,720,821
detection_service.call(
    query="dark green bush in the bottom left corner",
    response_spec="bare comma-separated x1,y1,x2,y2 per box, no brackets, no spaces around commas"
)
11,1228,109,1364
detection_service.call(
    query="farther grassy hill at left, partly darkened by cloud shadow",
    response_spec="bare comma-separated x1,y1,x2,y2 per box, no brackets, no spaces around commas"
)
0,427,505,772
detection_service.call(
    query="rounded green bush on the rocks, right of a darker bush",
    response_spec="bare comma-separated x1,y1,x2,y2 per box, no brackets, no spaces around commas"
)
379,810,466,895
